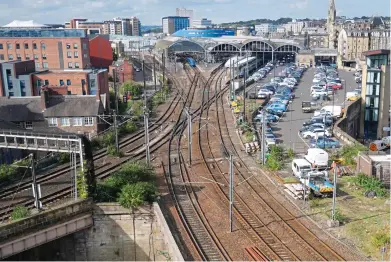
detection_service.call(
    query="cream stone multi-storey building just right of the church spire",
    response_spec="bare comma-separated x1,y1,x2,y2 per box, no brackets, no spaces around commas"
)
338,29,370,61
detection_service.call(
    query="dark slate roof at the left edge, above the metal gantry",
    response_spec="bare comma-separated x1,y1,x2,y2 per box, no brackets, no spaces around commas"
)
0,96,44,122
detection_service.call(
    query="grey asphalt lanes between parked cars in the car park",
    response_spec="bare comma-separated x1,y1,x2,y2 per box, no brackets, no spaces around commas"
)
272,68,357,153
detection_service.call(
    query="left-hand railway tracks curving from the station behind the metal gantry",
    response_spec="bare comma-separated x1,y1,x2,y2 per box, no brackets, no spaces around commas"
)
0,65,196,221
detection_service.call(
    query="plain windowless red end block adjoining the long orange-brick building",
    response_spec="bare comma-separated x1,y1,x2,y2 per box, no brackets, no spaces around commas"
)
90,35,113,68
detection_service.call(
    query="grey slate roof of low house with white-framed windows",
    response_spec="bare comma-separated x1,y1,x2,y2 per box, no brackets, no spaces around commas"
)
43,95,104,117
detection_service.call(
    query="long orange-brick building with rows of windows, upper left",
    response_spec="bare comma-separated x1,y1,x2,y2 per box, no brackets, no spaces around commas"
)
0,29,90,70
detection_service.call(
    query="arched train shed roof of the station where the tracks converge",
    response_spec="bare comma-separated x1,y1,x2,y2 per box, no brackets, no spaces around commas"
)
155,36,304,53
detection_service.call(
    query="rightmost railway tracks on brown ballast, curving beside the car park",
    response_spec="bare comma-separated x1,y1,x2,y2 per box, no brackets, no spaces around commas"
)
207,66,343,261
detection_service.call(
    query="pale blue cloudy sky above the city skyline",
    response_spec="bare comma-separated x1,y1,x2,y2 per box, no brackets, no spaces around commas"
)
0,0,390,25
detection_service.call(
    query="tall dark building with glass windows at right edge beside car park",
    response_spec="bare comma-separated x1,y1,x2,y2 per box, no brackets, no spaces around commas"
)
360,50,390,140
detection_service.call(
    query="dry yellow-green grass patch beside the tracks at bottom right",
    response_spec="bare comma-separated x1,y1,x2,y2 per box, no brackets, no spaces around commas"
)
308,177,390,259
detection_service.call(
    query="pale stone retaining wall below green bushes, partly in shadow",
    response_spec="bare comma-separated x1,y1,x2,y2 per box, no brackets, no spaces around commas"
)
75,203,176,261
